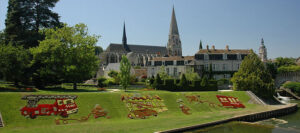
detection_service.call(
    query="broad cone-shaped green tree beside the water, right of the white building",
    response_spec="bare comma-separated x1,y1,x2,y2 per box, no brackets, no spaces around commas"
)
231,51,275,98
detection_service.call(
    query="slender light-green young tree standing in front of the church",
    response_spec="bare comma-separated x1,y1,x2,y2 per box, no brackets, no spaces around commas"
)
120,55,131,91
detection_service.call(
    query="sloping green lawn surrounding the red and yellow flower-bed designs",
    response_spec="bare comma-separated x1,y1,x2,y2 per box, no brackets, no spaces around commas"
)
0,90,264,133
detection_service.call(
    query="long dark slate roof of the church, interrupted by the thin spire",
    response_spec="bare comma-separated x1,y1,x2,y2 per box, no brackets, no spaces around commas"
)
106,43,167,55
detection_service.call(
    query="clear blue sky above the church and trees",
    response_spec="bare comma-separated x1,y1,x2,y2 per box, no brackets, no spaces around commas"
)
0,0,300,59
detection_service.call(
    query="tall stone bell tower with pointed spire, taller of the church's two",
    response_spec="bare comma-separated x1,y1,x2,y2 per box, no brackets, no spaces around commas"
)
167,7,182,56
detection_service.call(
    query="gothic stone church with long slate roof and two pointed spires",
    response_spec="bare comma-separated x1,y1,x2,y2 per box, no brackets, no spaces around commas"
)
100,7,182,67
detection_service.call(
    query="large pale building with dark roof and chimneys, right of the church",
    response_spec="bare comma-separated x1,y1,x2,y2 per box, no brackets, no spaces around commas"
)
194,45,250,79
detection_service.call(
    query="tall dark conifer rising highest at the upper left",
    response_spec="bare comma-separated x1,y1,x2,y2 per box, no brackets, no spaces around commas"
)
5,0,62,48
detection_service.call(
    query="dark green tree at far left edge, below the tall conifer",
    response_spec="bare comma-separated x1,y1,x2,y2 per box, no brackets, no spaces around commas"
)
0,45,30,86
